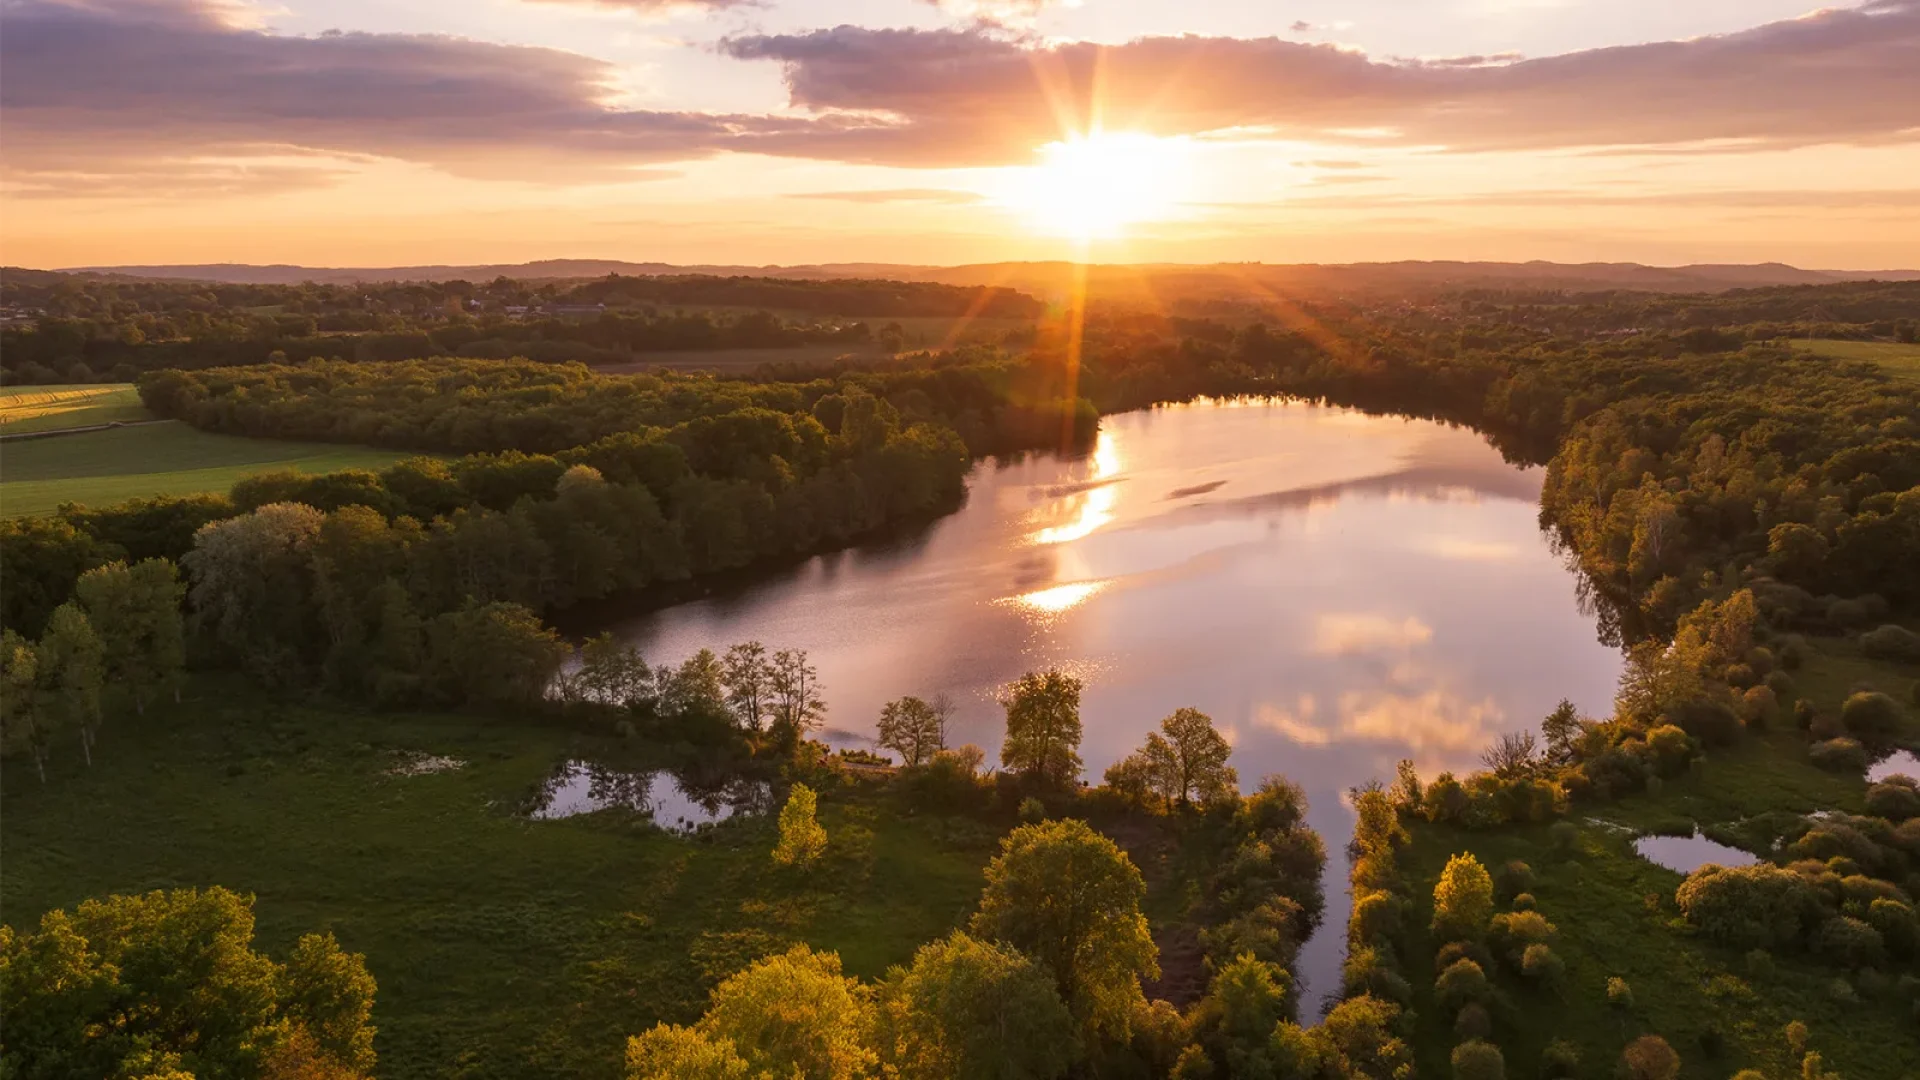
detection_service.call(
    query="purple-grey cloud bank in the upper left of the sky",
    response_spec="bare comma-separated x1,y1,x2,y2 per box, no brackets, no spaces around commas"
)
0,0,806,181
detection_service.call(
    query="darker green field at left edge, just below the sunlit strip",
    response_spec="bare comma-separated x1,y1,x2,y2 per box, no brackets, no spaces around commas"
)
0,423,418,517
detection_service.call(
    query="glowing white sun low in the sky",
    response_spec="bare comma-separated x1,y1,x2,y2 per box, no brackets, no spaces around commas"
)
996,133,1187,240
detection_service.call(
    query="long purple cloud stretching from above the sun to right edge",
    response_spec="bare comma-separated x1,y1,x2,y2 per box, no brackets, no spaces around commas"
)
720,0,1920,165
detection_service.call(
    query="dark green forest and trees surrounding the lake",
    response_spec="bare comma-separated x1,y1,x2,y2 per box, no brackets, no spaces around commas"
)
0,279,1920,1080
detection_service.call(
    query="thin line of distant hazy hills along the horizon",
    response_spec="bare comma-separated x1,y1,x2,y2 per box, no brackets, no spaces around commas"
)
30,259,1920,300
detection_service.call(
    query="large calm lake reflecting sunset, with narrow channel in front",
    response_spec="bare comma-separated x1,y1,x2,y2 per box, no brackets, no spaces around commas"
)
616,404,1620,995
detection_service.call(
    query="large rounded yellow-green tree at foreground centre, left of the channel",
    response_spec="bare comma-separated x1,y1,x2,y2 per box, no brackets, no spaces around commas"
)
970,819,1160,1040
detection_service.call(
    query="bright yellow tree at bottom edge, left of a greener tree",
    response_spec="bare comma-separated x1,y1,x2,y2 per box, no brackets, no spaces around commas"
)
699,945,874,1080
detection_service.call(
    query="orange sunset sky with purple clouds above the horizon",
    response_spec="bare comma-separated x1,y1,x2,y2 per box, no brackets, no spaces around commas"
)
0,0,1920,269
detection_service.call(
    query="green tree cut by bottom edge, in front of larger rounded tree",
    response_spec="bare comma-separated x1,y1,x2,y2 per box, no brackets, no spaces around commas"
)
877,930,1081,1080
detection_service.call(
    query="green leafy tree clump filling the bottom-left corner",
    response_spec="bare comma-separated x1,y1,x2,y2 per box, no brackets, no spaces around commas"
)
0,888,374,1080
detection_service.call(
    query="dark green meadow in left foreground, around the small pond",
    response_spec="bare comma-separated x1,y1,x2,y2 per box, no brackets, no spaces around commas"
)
0,678,1000,1080
